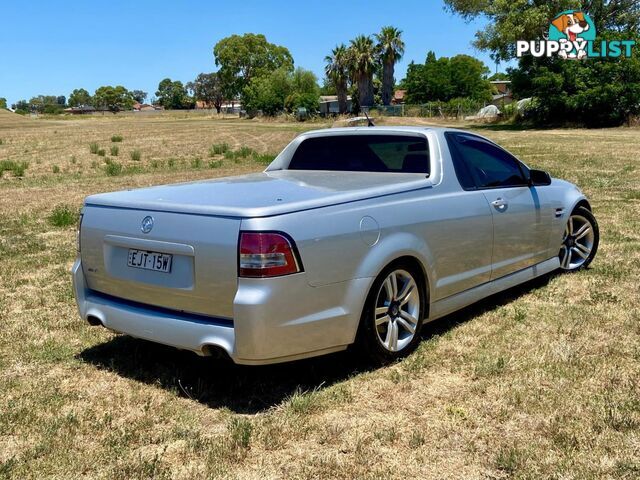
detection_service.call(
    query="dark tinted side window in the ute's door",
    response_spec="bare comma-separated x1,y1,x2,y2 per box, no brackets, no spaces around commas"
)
455,134,528,188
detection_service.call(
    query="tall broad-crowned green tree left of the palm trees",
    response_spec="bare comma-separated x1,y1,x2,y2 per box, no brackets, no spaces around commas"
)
213,33,293,98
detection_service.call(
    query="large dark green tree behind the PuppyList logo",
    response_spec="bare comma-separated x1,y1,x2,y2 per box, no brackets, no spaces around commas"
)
445,0,640,126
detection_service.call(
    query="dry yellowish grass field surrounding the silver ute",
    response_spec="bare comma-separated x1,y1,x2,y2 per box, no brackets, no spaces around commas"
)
0,112,640,479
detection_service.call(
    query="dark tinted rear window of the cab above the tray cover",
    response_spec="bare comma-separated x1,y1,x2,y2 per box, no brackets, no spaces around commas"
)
289,135,429,175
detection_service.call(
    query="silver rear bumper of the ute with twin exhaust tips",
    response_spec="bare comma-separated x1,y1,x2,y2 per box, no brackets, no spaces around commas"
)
71,259,372,365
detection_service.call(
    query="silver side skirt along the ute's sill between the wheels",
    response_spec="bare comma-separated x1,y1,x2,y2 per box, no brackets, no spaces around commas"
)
427,257,560,322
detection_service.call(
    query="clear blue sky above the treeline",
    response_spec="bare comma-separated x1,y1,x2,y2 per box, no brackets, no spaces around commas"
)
0,0,495,105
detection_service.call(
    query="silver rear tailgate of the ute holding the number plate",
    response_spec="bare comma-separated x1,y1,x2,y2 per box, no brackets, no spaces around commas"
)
80,205,240,318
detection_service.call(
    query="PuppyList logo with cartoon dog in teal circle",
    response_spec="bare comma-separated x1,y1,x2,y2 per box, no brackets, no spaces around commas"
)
516,10,636,60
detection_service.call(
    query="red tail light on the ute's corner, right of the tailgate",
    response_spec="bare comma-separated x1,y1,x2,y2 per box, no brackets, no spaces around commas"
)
238,232,302,278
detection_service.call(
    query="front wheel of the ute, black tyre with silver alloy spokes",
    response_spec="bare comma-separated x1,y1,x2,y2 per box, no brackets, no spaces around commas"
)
558,207,600,272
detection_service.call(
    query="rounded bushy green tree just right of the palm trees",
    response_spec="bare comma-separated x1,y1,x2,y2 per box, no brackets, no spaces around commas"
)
403,52,491,103
